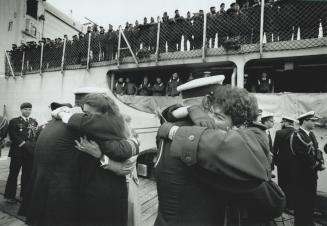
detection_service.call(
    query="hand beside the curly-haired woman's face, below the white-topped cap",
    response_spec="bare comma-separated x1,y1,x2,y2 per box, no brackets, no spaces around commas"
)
188,106,218,129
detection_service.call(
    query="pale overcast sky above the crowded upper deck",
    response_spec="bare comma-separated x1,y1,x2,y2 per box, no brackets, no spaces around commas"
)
47,0,233,29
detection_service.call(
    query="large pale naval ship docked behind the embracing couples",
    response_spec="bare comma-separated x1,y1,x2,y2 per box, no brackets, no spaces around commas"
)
0,1,327,224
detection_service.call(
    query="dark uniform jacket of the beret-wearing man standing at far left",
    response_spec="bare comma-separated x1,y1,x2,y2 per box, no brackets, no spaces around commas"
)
8,116,38,157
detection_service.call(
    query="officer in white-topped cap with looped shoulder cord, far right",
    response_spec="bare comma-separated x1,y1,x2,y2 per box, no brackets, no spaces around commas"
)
290,111,323,226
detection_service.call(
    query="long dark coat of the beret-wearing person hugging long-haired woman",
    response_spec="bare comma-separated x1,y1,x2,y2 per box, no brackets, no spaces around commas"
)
19,120,80,226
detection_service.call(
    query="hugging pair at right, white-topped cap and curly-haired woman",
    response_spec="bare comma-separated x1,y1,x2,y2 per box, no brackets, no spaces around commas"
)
155,75,285,226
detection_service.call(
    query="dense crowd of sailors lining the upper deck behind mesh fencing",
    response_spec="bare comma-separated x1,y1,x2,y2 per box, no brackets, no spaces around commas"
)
10,0,327,71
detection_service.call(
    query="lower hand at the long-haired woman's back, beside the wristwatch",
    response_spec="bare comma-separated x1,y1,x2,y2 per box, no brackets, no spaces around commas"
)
103,156,137,175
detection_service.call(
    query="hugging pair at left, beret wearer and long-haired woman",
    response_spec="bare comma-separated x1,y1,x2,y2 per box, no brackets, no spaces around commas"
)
19,94,138,226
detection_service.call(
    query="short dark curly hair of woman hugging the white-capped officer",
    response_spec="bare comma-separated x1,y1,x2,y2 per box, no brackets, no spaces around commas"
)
210,85,259,126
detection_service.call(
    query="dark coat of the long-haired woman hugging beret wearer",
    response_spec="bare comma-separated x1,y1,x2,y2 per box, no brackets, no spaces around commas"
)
67,114,138,226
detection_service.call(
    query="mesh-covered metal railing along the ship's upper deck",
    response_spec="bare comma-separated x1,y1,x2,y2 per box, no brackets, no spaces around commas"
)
5,1,327,76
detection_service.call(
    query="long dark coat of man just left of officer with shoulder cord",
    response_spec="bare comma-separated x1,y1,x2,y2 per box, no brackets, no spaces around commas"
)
273,127,295,208
